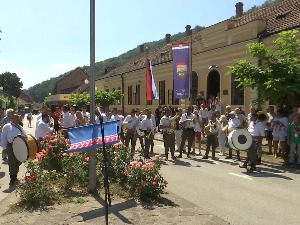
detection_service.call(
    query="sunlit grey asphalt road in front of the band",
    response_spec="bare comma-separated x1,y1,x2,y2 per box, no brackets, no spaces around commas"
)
0,116,300,225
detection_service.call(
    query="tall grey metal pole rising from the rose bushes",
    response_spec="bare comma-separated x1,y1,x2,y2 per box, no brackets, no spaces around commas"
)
89,0,96,192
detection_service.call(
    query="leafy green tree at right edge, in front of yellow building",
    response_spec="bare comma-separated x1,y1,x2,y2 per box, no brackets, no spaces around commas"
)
227,30,300,107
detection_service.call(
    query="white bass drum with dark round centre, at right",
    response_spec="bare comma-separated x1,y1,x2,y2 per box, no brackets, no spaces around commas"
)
228,129,252,151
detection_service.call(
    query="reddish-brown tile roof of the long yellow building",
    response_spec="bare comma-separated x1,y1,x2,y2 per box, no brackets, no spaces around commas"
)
99,0,300,80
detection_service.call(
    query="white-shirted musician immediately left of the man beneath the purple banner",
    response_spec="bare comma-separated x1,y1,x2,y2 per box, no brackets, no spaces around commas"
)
160,109,176,160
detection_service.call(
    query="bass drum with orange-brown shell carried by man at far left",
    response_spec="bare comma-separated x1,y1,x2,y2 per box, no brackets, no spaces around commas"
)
12,135,38,163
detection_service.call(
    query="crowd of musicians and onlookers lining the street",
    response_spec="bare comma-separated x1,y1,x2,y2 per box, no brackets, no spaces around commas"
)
0,95,300,184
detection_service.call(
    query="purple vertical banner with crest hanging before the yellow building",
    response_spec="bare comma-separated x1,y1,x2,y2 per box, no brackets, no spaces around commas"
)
172,43,190,99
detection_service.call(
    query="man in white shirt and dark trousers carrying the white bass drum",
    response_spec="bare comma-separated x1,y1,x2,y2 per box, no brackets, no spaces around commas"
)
239,113,265,172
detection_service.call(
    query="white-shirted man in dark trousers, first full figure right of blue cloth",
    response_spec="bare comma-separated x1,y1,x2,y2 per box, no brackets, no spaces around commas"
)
123,109,139,154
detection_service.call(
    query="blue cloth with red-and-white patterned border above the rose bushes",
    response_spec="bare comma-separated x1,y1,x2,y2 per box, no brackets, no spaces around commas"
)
66,121,119,153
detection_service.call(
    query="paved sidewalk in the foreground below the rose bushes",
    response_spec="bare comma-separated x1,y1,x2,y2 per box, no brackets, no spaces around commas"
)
0,189,229,225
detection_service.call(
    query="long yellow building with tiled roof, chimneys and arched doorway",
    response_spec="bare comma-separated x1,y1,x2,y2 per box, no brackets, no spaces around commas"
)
96,0,300,113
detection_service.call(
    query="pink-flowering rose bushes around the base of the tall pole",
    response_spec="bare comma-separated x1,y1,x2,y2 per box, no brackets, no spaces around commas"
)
18,133,167,205
